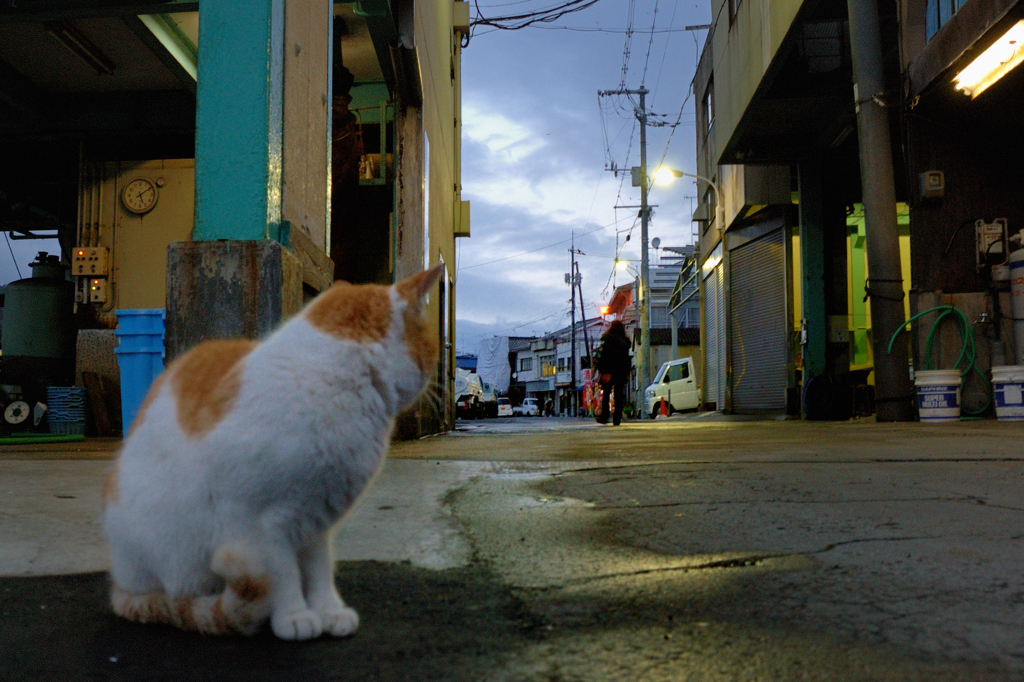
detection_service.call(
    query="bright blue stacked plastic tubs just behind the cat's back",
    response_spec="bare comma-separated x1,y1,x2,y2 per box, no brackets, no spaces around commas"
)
114,308,167,434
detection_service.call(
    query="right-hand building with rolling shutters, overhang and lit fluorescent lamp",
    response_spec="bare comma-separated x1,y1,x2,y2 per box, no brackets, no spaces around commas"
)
693,0,1024,419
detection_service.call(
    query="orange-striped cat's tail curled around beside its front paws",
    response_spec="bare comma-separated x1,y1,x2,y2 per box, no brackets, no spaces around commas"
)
111,547,270,635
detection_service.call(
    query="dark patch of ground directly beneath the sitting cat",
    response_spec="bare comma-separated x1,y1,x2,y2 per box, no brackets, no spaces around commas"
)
0,562,537,682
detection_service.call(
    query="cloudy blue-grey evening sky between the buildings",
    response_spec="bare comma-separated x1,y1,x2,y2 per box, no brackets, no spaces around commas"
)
456,0,710,352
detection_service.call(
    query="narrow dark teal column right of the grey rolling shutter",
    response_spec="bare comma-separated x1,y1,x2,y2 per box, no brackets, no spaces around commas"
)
800,163,827,378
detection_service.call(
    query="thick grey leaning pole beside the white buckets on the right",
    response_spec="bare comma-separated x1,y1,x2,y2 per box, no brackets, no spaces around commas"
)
849,0,914,422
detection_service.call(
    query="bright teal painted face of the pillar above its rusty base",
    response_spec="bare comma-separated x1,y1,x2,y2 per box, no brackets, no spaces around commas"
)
193,0,285,241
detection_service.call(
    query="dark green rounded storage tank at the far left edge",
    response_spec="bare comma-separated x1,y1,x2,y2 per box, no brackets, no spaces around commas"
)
2,251,76,392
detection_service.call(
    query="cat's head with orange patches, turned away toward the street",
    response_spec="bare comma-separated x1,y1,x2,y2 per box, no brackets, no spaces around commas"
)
303,264,444,409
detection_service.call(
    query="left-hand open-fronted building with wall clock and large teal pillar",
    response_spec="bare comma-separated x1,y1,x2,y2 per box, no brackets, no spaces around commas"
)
0,0,469,436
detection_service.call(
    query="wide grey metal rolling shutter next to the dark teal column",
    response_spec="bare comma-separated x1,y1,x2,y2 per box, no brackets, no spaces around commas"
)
729,229,788,413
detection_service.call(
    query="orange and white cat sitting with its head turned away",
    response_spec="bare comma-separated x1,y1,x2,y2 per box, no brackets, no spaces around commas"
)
103,266,443,639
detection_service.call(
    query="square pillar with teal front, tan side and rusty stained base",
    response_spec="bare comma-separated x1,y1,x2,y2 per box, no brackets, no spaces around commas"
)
167,0,333,358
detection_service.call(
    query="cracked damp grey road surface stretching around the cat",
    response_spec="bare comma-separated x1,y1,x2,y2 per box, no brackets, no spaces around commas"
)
0,418,1024,680
